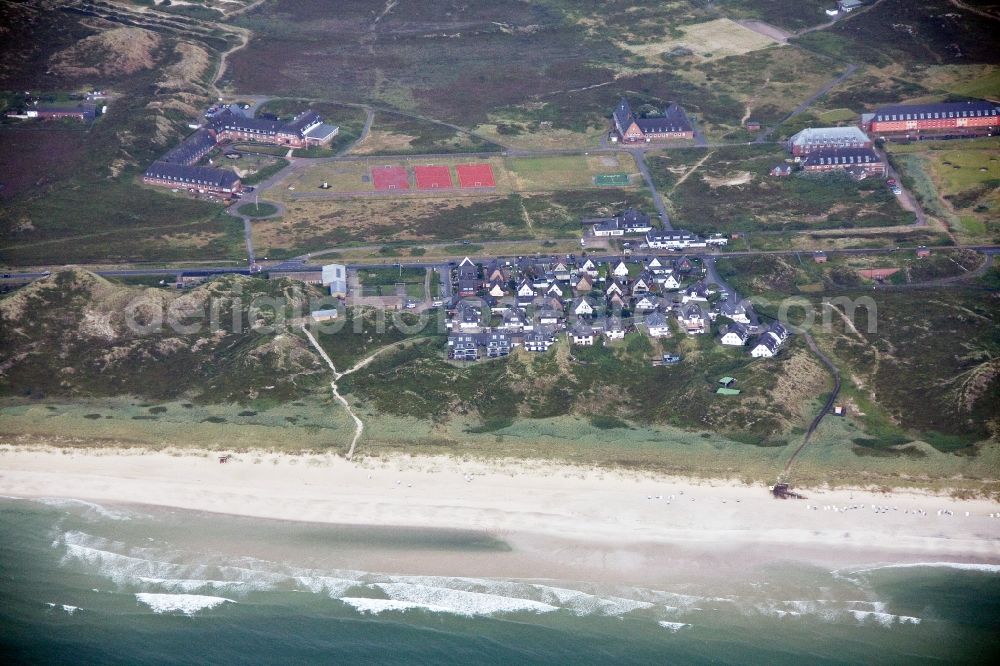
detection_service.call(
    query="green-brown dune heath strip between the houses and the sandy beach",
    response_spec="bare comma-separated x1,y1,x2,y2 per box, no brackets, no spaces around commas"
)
0,268,998,491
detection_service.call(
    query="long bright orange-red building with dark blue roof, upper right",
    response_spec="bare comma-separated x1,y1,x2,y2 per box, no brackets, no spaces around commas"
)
863,101,1000,137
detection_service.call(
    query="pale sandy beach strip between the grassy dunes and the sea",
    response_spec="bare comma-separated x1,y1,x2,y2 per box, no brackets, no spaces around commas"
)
0,447,1000,577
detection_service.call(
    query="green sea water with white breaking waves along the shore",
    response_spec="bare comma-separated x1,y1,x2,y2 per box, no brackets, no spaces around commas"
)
0,498,1000,664
